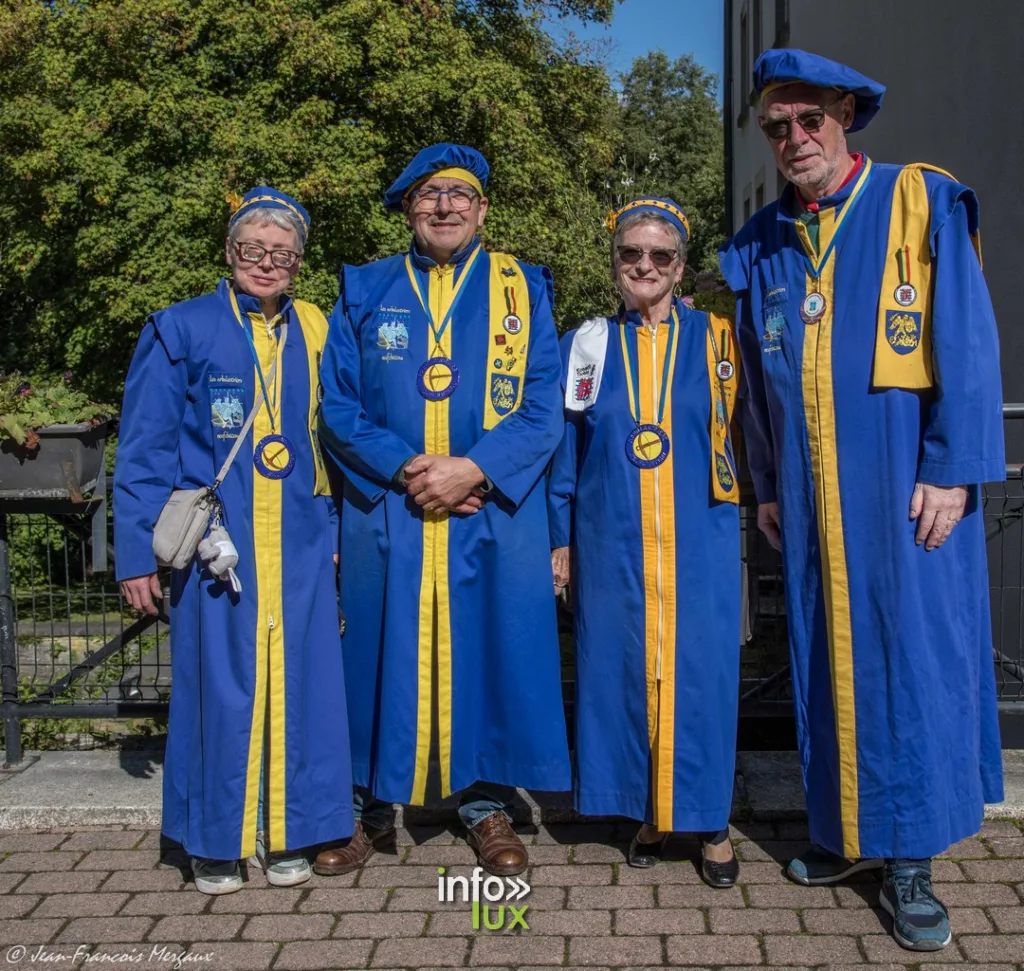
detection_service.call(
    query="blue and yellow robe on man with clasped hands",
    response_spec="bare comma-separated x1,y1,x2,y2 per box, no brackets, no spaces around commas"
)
321,236,569,805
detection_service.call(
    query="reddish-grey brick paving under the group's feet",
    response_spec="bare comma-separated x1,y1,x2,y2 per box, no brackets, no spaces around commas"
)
0,821,1024,971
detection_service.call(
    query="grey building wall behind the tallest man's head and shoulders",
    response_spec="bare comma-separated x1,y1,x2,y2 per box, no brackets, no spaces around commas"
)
726,0,1024,421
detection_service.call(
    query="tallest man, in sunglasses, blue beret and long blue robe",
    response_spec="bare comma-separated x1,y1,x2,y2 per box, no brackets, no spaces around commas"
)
721,49,1005,951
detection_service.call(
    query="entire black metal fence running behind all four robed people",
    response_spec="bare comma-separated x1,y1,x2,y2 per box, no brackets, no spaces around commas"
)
0,406,1024,763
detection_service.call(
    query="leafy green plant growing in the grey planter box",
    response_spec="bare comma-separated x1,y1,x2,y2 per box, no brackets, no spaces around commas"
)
0,371,117,450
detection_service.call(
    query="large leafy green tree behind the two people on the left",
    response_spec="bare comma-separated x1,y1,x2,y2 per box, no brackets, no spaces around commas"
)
0,0,613,397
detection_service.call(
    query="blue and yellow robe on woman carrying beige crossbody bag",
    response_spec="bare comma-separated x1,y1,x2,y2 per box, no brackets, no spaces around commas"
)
114,281,352,859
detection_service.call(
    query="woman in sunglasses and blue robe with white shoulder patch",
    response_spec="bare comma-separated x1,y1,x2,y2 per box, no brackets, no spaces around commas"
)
548,199,740,887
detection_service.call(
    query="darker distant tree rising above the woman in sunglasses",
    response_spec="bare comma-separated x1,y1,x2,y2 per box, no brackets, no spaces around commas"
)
608,51,725,271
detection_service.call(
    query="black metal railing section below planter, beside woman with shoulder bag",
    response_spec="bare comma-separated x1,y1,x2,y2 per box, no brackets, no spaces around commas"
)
0,483,171,764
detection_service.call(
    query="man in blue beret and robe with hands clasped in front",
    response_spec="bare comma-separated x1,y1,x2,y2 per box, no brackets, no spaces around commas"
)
314,144,569,876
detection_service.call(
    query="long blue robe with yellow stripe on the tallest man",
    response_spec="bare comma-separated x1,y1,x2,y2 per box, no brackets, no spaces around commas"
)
721,161,1005,858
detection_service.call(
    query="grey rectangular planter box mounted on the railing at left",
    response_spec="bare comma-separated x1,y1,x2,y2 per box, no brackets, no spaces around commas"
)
0,420,112,502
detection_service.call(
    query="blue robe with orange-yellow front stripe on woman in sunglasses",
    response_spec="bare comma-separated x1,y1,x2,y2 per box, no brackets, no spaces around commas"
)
548,302,741,832
